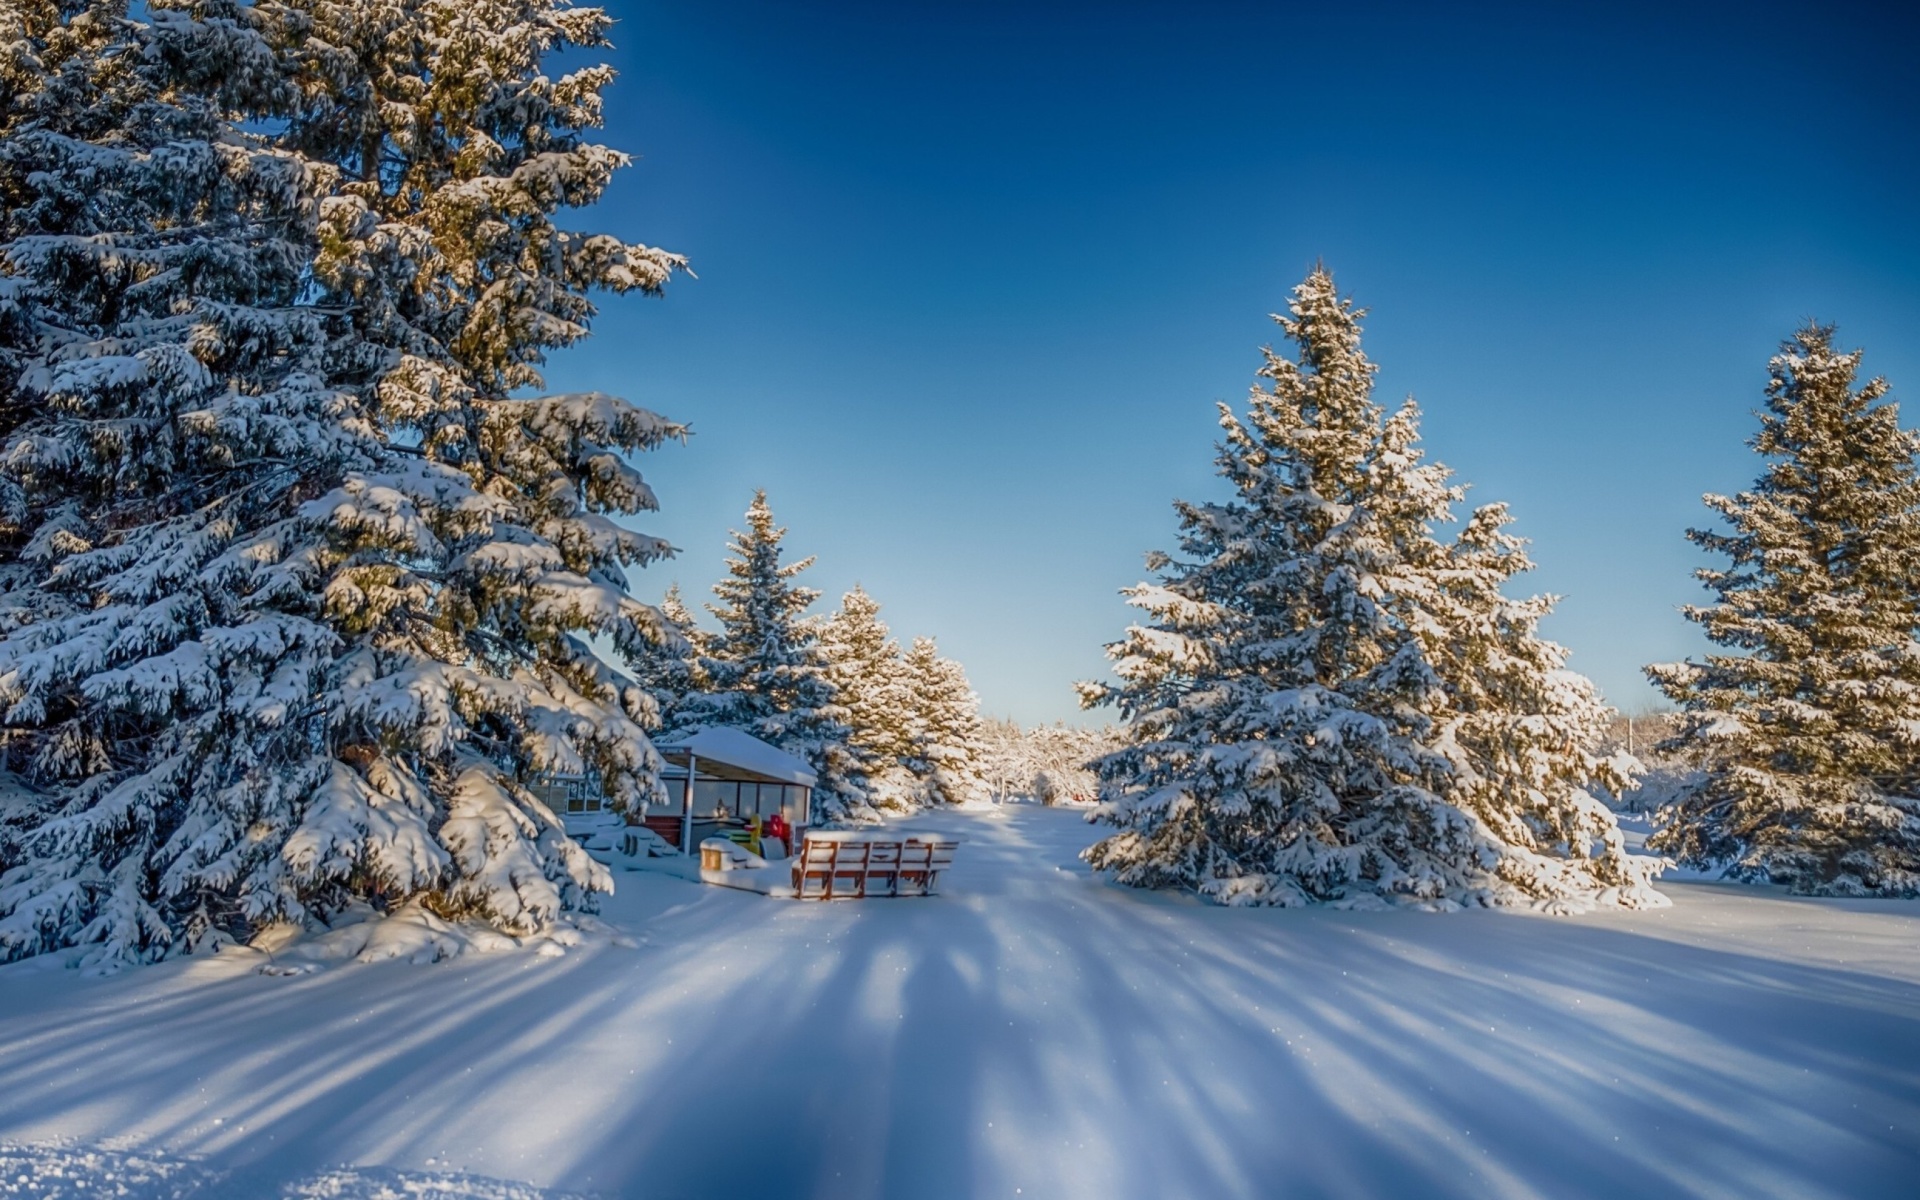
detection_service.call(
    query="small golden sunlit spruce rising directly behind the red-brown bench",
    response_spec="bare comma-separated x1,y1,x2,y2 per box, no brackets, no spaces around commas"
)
820,586,920,808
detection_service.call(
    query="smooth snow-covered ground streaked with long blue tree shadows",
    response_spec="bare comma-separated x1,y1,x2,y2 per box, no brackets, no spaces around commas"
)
0,806,1920,1200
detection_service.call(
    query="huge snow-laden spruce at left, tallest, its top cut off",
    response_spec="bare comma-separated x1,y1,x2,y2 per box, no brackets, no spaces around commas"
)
0,2,680,962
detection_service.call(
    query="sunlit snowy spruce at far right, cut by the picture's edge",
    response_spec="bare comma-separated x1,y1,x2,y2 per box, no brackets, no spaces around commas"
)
1647,324,1920,897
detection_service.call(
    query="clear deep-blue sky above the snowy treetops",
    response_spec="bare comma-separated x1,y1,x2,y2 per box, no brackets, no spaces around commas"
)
549,0,1920,720
